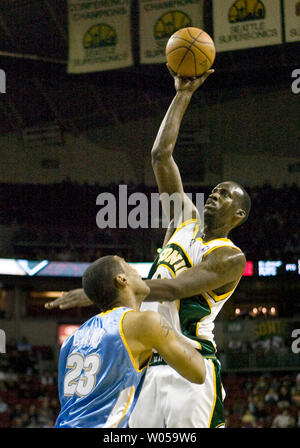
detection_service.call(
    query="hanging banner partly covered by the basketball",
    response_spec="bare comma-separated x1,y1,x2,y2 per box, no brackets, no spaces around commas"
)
139,0,203,64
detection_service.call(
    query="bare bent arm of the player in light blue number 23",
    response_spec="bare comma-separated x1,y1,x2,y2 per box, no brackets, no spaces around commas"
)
123,311,206,384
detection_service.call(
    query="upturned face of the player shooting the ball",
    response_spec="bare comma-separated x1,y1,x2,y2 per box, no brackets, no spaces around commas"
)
204,182,242,224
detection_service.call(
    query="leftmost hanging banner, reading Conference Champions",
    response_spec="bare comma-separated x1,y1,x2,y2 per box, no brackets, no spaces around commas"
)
68,0,133,73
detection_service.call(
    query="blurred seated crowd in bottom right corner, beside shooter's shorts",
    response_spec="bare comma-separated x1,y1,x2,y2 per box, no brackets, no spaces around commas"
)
223,372,300,428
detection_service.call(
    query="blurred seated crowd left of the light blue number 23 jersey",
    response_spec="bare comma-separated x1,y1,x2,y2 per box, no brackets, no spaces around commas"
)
0,338,60,428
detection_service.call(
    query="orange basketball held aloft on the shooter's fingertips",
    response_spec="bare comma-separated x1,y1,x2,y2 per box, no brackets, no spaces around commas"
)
166,27,216,78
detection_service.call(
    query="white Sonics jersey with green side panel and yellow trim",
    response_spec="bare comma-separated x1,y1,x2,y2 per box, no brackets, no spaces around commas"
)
142,219,240,365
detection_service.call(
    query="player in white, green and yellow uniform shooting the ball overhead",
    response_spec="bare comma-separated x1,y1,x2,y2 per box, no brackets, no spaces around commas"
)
48,67,250,428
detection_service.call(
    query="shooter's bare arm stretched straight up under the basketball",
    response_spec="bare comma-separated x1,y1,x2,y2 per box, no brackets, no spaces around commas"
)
151,66,214,224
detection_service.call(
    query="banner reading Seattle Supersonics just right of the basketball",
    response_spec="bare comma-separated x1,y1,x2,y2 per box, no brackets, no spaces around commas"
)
213,0,282,52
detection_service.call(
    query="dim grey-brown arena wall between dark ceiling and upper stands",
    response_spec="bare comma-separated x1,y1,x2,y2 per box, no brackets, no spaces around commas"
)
0,88,300,186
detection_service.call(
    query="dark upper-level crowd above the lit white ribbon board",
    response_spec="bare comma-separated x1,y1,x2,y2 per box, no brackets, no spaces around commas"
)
0,179,300,261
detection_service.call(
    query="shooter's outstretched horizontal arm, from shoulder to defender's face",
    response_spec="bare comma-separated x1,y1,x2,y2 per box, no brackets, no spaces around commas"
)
145,247,246,302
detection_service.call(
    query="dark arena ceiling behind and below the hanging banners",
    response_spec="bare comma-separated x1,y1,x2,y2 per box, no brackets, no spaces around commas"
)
0,0,300,133
